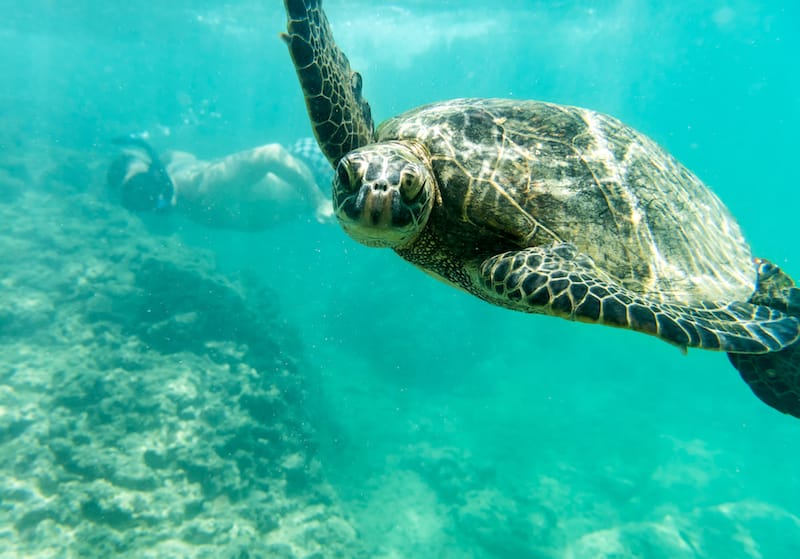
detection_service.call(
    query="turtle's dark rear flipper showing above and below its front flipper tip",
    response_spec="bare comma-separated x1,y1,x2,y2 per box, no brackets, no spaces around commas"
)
728,259,800,418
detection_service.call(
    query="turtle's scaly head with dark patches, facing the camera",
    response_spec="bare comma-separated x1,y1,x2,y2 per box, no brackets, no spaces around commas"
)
333,142,436,248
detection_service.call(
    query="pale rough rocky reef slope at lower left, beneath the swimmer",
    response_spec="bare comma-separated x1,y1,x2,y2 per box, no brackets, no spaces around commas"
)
0,165,356,558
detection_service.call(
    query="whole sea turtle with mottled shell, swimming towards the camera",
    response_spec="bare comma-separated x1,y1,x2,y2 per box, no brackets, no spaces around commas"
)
282,0,800,417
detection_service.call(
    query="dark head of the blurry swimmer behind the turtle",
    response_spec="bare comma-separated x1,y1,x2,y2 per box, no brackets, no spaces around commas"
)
106,153,174,212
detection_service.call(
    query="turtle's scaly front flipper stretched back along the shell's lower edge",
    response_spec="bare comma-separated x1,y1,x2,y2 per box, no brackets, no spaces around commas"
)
481,244,800,353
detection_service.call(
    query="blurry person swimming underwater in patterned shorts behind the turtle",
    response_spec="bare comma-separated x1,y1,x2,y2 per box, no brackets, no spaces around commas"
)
107,135,333,231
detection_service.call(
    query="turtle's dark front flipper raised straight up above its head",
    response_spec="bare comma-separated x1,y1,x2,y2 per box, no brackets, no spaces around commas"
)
281,0,374,167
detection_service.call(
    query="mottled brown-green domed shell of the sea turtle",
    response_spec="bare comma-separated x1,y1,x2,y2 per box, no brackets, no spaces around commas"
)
376,99,755,304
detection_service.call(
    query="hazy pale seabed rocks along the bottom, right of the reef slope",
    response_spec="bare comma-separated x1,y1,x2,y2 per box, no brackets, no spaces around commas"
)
340,444,800,559
